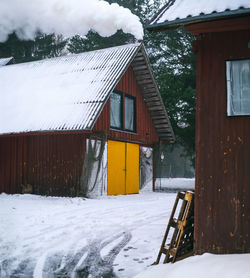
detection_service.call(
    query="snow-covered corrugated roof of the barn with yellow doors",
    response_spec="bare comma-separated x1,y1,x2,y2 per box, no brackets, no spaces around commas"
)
0,43,174,141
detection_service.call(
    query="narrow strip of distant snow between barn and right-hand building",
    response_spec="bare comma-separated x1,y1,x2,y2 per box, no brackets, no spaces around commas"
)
155,178,195,192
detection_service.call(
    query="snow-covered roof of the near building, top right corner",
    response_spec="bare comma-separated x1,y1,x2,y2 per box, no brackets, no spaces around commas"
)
147,0,250,29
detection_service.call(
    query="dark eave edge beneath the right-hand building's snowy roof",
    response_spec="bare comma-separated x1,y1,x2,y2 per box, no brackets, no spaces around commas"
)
146,9,250,31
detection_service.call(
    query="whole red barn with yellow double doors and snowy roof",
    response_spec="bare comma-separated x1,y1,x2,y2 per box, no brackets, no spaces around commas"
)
0,43,174,196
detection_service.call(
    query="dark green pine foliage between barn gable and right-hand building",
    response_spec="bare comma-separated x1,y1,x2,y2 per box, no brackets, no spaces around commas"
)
144,28,196,162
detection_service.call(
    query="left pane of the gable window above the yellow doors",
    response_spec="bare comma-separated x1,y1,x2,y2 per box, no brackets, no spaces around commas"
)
110,93,122,128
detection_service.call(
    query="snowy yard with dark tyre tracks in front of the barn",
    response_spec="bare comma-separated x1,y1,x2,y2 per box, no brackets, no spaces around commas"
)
0,193,176,278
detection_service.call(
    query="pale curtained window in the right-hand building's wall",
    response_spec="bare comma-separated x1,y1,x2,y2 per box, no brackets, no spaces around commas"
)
226,59,250,116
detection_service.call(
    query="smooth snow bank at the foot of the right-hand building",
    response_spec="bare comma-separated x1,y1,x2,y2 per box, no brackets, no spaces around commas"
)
134,254,250,278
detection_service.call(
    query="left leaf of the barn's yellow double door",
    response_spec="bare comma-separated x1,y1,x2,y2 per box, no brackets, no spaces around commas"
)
107,140,126,195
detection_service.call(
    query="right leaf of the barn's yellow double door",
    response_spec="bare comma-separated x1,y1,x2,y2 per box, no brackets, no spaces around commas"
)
126,143,139,194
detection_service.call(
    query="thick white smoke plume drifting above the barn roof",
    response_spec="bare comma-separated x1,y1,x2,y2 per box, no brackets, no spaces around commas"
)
0,0,143,42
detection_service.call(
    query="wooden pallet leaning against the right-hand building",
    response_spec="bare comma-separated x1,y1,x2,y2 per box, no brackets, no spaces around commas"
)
154,191,194,264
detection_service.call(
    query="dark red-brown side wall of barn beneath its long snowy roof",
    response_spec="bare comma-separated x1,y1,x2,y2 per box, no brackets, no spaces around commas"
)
0,134,86,196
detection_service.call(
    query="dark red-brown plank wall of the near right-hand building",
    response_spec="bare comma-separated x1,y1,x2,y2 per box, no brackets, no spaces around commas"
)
195,30,250,253
